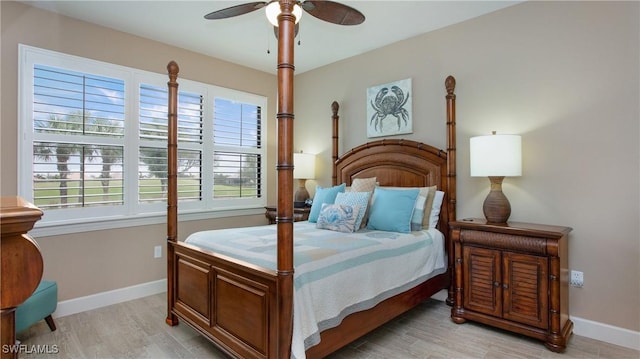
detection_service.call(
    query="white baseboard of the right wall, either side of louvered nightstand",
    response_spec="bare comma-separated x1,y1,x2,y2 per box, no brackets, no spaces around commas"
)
431,289,640,350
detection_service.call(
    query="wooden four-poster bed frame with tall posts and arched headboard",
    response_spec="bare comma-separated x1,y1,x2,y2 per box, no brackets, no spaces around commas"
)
166,0,456,358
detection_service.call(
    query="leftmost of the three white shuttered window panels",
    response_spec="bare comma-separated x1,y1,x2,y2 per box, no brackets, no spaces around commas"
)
32,65,125,209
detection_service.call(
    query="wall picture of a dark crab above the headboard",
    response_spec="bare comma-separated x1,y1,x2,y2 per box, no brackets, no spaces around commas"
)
367,78,413,137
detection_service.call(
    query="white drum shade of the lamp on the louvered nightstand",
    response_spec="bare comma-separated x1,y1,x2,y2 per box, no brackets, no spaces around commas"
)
469,135,522,177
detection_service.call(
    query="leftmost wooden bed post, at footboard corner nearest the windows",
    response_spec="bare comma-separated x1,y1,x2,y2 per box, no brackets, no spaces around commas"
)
166,61,180,326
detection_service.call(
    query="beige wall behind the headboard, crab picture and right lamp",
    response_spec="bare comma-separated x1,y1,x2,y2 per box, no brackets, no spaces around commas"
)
295,2,640,331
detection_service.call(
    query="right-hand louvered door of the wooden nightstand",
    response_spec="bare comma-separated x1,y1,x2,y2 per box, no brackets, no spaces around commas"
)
502,252,549,329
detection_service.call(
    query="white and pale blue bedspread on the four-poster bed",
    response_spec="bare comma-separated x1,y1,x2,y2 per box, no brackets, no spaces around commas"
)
186,221,446,359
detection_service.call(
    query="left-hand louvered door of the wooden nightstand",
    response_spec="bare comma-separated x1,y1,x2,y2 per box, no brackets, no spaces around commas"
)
462,247,502,316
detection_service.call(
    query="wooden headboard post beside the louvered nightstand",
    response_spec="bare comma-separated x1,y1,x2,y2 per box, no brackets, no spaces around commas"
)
444,75,457,305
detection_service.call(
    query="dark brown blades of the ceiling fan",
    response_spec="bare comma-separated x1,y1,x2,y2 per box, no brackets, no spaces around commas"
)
204,0,364,25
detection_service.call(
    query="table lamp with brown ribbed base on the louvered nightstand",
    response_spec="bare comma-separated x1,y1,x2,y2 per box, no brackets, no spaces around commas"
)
469,131,522,224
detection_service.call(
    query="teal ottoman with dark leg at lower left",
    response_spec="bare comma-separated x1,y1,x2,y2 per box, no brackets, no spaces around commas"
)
16,280,58,333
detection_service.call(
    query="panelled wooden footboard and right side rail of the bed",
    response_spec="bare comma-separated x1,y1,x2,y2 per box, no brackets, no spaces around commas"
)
168,236,449,359
